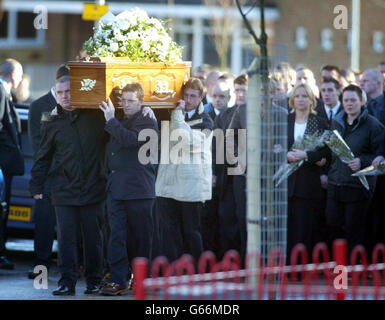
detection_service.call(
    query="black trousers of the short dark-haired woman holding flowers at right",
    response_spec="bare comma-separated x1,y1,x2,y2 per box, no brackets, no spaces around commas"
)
326,185,372,264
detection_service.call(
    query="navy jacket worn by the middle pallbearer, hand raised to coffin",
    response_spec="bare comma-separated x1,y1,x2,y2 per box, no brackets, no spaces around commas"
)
105,112,158,200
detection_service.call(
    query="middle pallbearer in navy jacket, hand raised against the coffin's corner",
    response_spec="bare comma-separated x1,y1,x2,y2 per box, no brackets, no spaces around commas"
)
100,83,158,296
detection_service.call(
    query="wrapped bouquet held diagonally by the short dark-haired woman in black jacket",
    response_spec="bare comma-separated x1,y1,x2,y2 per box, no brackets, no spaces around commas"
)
325,130,369,190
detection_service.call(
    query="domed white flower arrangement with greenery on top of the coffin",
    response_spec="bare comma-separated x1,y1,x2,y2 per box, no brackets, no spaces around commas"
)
83,8,183,63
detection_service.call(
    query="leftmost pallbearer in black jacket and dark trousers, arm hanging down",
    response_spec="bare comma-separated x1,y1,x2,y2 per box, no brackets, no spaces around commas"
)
30,76,106,295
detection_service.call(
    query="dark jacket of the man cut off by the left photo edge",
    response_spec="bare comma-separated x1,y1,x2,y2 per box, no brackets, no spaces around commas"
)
0,83,24,175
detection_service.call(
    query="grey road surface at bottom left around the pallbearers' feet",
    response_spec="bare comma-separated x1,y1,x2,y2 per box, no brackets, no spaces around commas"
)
0,239,133,300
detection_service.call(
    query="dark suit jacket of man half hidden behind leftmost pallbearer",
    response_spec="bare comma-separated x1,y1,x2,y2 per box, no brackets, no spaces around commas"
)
28,91,56,155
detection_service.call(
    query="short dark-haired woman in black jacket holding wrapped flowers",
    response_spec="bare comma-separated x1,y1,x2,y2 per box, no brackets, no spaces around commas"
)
326,85,384,262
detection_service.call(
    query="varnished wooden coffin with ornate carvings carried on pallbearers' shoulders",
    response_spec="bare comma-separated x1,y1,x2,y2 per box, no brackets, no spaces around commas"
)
68,57,191,109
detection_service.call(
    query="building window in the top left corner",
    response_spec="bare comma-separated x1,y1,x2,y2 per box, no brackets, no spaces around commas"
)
0,11,45,49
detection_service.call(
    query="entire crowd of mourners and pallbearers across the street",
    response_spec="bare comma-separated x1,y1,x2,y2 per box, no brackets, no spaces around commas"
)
0,59,385,295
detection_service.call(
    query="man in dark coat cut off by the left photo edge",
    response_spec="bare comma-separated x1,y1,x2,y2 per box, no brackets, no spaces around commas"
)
0,59,24,269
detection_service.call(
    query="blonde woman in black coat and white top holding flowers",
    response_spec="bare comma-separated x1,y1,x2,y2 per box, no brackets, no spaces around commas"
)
287,83,329,261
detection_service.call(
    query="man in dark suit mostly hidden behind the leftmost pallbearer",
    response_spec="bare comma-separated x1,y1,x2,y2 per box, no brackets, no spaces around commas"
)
28,65,70,279
